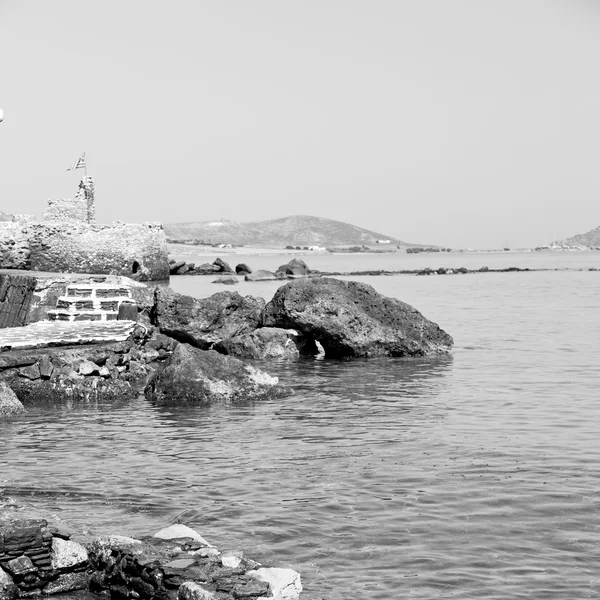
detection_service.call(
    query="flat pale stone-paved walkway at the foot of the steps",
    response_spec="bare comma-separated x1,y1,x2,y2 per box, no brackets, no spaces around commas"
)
0,321,136,352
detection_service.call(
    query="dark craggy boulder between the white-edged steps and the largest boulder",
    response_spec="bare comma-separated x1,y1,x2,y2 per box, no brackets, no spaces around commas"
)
152,288,265,350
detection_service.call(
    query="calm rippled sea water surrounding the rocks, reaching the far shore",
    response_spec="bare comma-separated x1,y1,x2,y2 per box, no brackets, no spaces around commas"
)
0,252,600,600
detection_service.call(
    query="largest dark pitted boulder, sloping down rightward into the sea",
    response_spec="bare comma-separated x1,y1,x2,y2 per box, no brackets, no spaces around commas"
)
263,277,453,357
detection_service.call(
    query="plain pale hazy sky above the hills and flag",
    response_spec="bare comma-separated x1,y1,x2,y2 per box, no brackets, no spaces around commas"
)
0,0,600,248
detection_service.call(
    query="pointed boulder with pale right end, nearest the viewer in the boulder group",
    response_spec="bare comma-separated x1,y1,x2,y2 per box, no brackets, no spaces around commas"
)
145,344,284,405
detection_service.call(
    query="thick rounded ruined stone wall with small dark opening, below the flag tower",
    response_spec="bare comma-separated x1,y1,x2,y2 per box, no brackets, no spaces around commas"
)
25,222,169,281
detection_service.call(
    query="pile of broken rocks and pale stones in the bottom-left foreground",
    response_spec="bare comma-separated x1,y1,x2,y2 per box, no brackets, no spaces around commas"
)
0,519,302,600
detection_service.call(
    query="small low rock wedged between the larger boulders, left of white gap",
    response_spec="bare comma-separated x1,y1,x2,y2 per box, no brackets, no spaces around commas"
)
215,327,318,359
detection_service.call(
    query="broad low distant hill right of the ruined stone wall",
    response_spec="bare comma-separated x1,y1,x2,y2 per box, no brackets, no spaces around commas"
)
163,215,417,247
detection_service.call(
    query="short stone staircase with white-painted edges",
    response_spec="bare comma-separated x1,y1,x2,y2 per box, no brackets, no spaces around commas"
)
48,283,135,322
